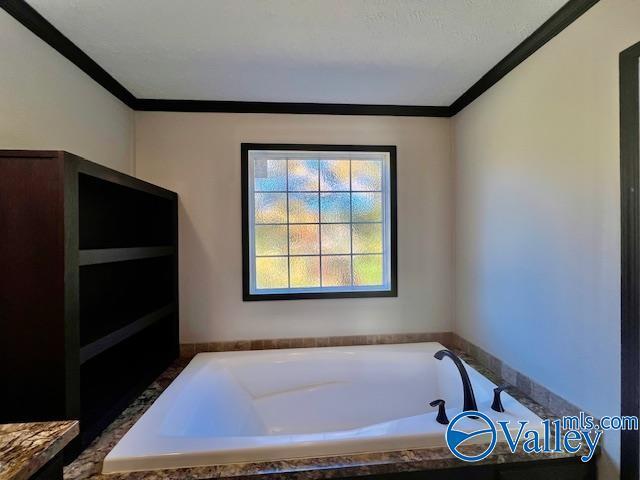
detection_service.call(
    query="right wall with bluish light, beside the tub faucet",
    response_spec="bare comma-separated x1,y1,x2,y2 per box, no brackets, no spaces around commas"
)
453,0,640,479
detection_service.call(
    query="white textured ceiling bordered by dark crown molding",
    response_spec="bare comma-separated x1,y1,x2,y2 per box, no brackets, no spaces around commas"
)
28,0,566,105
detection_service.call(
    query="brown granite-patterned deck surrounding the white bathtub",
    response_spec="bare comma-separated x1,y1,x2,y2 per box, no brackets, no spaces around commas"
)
64,350,582,480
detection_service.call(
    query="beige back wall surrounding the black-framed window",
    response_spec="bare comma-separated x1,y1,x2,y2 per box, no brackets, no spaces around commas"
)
136,112,452,342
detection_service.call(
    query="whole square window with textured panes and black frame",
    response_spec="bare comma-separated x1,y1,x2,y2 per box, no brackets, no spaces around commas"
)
242,144,397,300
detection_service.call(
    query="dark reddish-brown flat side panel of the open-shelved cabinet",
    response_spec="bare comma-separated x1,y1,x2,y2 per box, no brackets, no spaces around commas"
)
0,156,65,423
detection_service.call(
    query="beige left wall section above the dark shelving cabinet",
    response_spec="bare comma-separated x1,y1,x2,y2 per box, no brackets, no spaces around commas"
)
0,10,134,173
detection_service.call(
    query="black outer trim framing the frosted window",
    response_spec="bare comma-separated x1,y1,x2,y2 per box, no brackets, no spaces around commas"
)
240,143,398,301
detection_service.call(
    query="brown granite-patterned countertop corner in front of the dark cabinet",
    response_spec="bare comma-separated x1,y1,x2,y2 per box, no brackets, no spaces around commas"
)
0,420,79,480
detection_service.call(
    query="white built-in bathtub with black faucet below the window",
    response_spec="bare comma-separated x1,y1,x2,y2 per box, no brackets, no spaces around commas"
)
103,342,540,473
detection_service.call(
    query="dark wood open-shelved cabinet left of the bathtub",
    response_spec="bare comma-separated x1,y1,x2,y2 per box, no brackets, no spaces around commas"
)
0,150,179,458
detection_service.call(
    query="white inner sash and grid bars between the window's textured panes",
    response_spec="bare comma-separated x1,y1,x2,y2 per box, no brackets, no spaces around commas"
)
248,150,394,295
